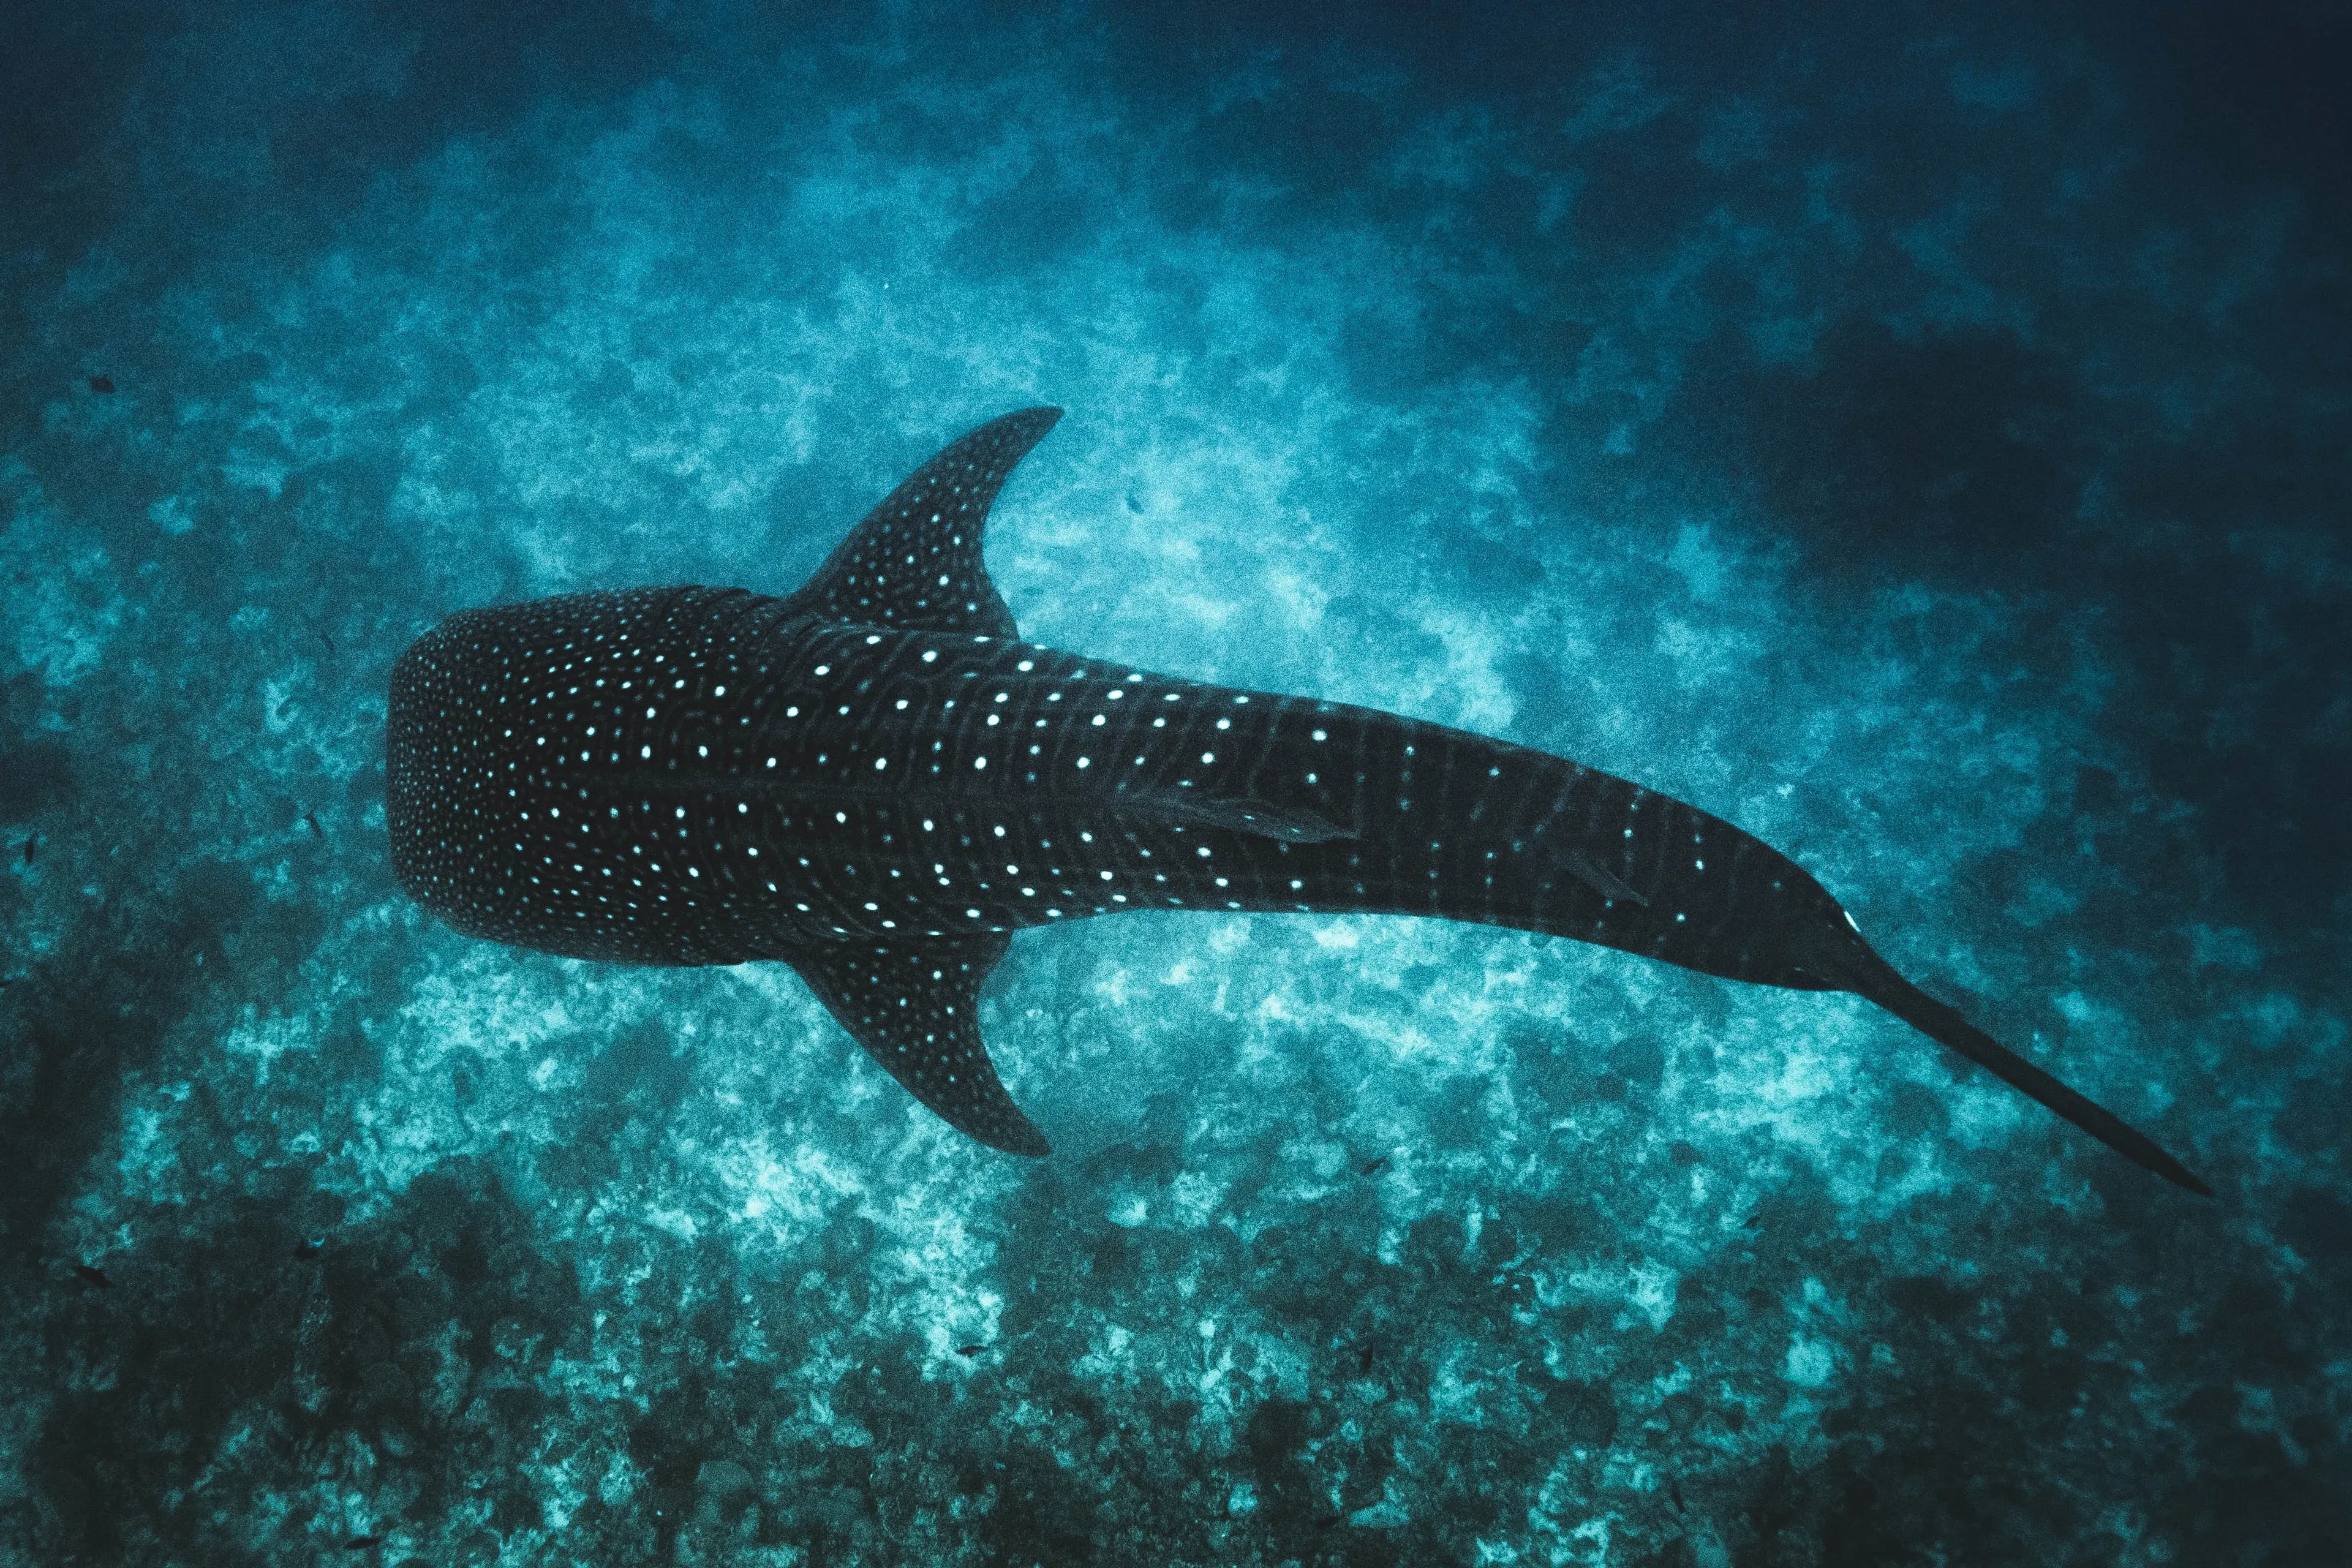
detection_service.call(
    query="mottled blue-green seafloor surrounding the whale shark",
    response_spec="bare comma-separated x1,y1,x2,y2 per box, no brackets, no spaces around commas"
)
0,0,2352,1568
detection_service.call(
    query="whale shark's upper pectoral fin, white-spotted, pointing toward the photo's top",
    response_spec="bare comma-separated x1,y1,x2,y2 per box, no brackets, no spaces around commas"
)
786,409,1061,637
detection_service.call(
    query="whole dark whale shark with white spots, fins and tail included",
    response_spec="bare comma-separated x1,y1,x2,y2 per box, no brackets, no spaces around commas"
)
386,409,2209,1192
